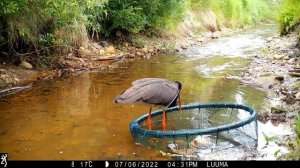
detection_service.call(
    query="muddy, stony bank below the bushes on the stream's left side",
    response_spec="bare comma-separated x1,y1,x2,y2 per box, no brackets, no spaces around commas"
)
0,25,237,90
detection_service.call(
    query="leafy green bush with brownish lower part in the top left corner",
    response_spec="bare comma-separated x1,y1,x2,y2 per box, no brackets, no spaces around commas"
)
0,0,104,51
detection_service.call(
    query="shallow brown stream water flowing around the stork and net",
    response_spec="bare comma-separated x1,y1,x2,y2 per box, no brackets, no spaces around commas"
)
0,26,290,160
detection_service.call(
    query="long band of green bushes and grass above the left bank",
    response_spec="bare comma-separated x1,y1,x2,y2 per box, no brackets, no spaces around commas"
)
0,0,276,55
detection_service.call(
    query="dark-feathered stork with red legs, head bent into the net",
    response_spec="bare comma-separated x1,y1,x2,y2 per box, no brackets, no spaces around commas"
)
113,78,182,131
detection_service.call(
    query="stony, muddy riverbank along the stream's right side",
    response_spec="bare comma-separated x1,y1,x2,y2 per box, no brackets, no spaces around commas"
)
241,28,300,159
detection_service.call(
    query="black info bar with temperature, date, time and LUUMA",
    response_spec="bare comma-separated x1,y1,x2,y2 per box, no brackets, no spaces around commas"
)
0,160,300,168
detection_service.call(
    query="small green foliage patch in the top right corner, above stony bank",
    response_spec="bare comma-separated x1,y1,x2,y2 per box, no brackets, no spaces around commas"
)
279,0,300,35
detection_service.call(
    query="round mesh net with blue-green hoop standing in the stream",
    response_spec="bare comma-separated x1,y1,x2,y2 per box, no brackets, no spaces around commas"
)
130,103,258,159
